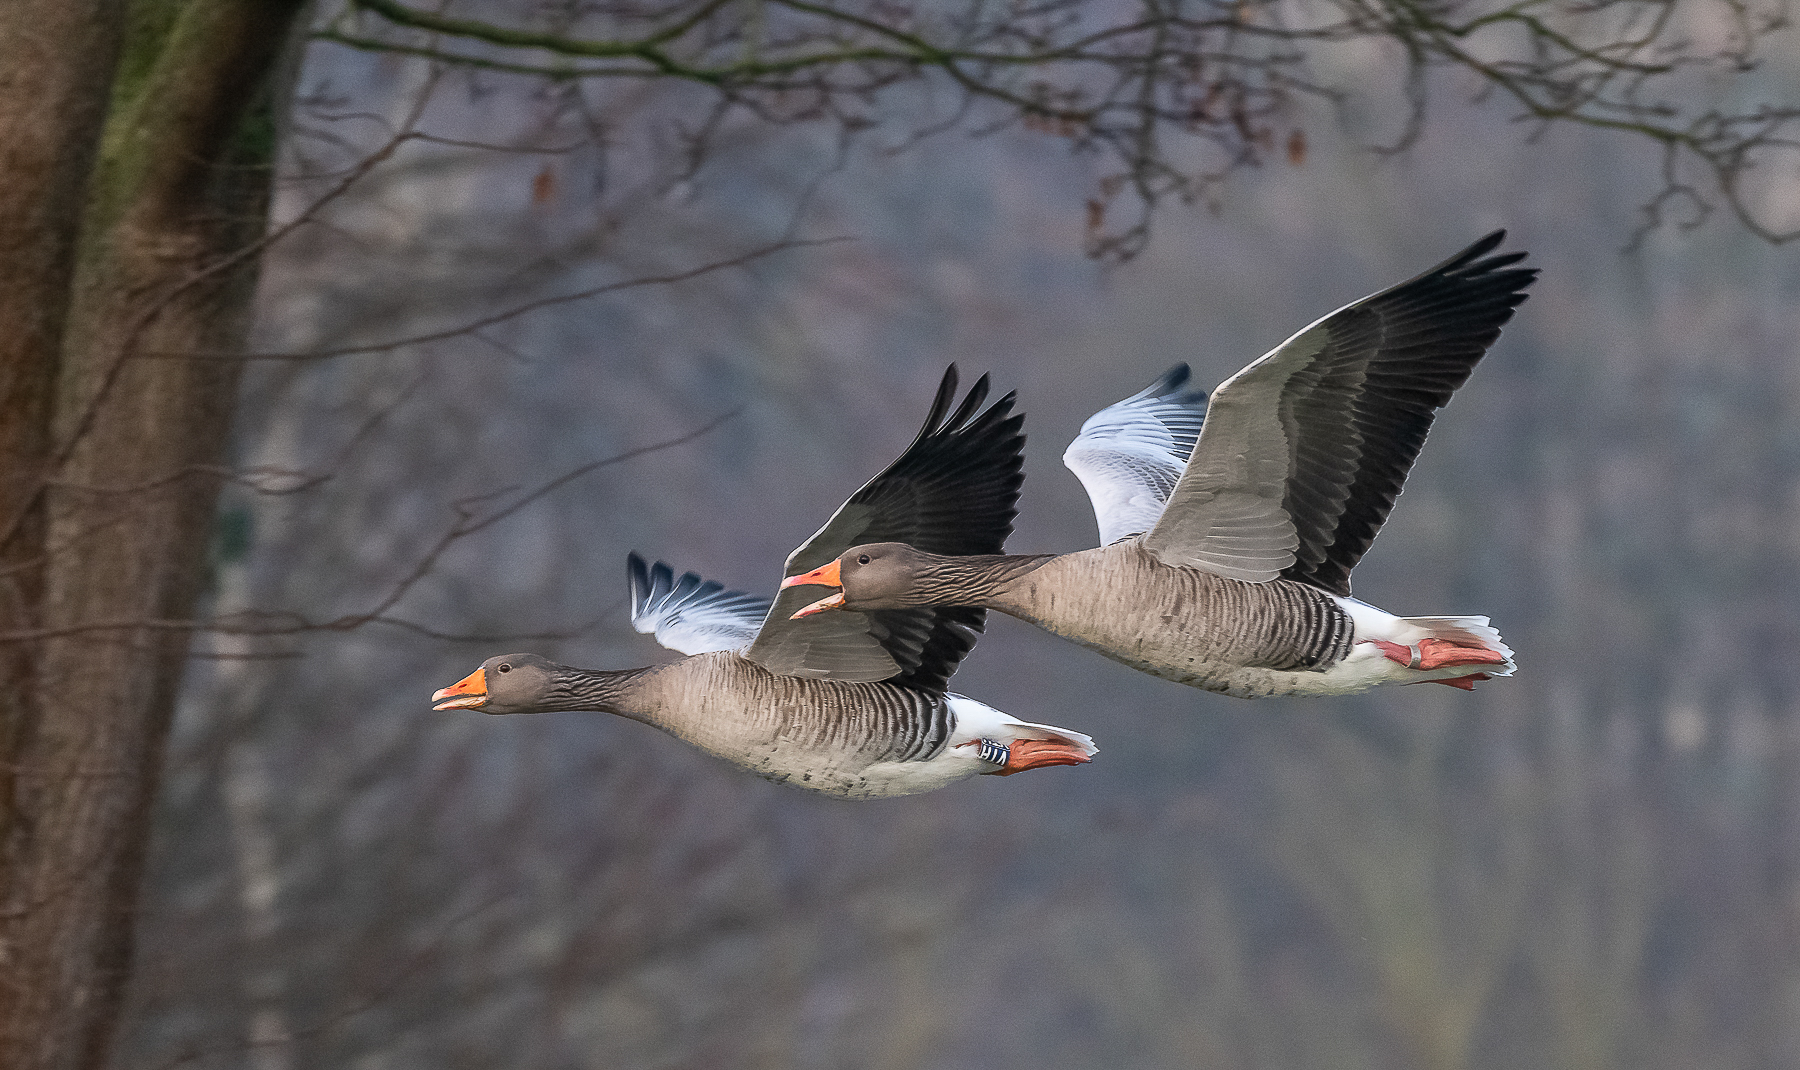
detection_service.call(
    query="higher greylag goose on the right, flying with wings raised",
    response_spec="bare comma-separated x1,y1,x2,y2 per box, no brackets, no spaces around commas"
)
783,231,1537,697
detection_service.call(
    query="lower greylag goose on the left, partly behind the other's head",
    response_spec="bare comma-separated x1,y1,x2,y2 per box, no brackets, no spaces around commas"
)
432,366,1094,798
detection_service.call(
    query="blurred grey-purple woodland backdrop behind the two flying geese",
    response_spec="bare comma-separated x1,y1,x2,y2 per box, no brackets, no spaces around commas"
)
59,0,1800,1070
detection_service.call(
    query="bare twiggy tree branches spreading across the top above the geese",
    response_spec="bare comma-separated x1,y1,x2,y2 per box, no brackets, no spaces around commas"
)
315,0,1800,259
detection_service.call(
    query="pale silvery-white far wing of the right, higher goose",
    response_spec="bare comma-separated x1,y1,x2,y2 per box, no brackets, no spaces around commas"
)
1062,364,1206,546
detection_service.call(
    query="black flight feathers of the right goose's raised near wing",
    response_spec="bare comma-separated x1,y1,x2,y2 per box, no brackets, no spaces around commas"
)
1282,231,1537,594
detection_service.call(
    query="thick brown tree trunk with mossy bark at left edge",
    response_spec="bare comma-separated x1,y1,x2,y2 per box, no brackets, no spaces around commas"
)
0,0,301,1070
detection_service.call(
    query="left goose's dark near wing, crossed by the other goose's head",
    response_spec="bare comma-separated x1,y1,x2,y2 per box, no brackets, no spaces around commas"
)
745,364,1024,692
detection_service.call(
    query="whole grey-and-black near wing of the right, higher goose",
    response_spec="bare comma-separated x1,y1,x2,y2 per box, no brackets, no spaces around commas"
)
1145,231,1537,594
